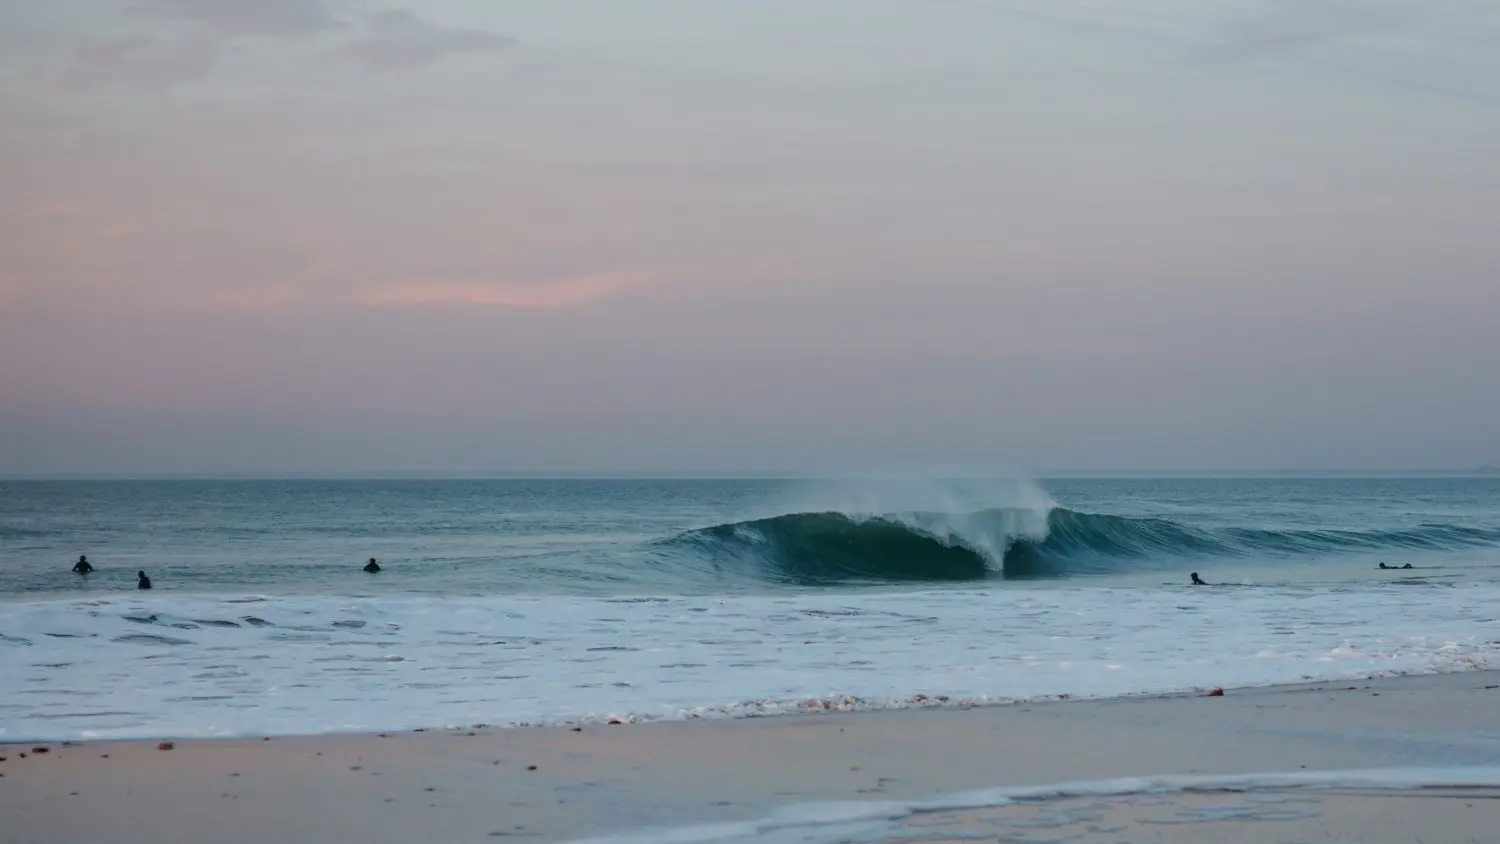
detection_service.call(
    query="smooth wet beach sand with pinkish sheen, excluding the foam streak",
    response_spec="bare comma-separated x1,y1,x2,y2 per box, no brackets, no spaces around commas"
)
0,672,1500,844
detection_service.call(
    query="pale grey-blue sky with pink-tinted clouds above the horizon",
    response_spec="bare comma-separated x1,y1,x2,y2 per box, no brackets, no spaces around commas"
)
0,0,1500,474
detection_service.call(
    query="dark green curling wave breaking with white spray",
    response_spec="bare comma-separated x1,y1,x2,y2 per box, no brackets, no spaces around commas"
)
665,507,1500,586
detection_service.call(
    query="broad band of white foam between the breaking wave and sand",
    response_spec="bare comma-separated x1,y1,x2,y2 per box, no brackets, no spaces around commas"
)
0,585,1500,741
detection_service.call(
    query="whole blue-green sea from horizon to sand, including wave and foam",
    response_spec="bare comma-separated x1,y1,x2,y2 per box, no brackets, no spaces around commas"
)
0,475,1500,741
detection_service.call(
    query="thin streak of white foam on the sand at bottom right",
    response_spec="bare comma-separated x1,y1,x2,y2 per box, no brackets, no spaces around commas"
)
570,766,1500,844
